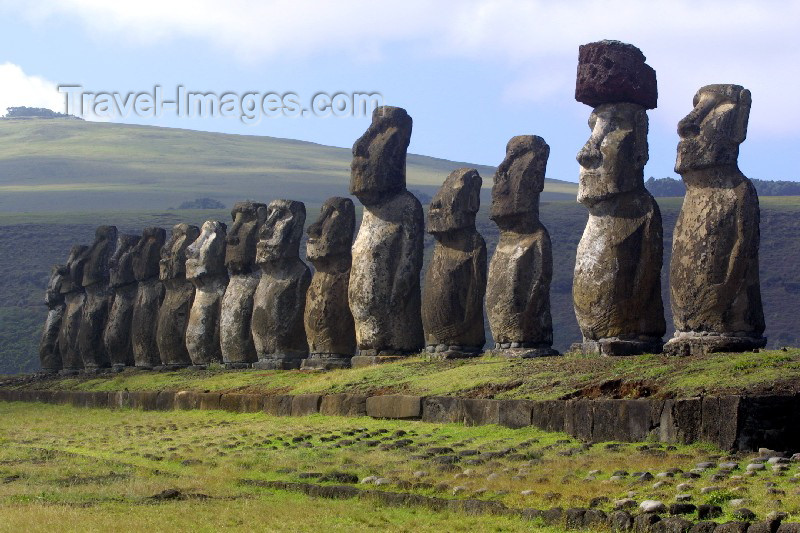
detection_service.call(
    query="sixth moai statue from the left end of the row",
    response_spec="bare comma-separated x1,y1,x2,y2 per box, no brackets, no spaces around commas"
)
156,224,200,368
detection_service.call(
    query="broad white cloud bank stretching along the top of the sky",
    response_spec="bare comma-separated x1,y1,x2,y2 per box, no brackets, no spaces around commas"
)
0,0,800,135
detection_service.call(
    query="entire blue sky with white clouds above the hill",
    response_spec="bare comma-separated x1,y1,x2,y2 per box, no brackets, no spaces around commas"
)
0,0,800,181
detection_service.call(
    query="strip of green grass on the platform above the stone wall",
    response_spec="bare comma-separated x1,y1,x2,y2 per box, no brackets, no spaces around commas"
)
9,348,800,400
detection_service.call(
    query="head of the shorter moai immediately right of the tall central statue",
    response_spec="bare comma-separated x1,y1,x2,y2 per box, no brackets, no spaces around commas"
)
428,168,483,235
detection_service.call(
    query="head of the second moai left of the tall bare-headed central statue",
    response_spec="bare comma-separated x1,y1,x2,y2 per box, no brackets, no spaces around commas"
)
256,200,306,264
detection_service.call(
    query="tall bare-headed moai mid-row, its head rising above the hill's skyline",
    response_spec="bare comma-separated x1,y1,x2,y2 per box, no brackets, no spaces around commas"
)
348,106,425,367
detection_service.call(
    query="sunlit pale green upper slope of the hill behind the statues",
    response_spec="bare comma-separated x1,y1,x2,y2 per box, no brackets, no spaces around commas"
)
0,119,577,212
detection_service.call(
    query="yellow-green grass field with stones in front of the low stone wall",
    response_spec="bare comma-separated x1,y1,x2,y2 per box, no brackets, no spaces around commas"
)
0,403,800,531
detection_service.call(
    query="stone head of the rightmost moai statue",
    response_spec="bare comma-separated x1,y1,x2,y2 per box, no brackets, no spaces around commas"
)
675,84,751,173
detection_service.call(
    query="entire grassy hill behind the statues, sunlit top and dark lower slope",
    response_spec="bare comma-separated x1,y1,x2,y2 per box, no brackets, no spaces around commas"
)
0,120,800,374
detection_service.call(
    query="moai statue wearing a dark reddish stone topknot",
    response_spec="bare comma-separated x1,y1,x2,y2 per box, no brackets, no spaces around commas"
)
572,41,666,355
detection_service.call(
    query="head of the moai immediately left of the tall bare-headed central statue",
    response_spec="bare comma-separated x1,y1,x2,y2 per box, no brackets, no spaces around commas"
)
306,196,356,262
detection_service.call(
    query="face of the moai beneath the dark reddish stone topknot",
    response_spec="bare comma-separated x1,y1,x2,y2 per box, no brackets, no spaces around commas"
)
577,103,648,206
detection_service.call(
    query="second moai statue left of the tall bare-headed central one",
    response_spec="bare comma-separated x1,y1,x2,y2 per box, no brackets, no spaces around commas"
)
251,200,311,370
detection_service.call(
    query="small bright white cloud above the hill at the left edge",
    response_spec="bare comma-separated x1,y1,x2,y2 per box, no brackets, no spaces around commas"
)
0,63,64,115
